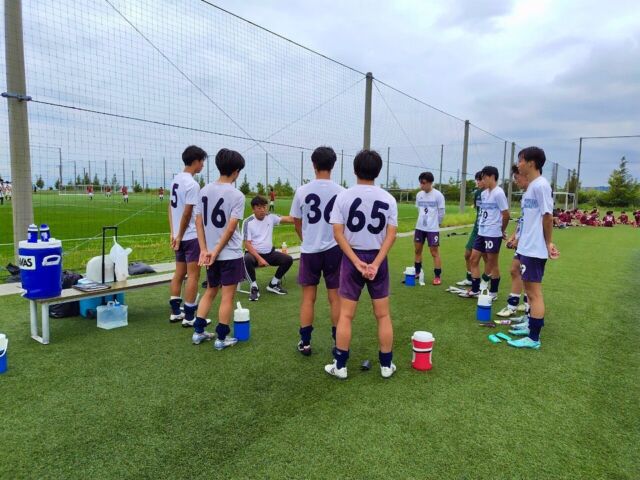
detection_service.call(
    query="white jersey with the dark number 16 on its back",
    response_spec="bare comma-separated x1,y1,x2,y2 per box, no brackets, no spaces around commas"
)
196,183,244,260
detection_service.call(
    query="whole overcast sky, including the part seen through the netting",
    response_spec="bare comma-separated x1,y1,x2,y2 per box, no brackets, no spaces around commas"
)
0,0,640,187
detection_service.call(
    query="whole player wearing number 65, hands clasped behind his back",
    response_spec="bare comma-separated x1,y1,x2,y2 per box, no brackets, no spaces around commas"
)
325,150,398,379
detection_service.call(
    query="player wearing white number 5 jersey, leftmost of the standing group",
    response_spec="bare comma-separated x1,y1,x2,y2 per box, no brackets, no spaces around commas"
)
168,145,207,327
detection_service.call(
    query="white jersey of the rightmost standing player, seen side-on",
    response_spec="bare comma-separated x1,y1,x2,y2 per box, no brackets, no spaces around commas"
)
516,175,553,258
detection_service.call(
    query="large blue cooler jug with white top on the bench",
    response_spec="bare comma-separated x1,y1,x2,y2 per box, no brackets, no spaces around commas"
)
18,238,62,300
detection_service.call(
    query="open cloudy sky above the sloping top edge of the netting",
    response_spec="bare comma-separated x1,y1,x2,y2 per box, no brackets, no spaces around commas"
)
214,0,640,185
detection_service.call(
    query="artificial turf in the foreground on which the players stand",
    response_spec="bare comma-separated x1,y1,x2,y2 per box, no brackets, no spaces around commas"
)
0,224,640,479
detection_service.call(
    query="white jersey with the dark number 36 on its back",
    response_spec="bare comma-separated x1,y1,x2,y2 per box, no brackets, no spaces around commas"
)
289,180,344,253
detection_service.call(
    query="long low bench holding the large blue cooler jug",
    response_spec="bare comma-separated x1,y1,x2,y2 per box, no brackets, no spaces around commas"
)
29,273,173,345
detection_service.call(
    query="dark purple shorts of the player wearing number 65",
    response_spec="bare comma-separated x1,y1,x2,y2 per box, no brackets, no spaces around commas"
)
338,250,389,302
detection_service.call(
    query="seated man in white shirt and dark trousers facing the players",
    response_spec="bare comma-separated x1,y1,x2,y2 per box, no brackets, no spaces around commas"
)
242,195,293,296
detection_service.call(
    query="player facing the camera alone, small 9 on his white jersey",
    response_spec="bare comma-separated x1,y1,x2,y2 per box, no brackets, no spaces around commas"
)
413,172,445,285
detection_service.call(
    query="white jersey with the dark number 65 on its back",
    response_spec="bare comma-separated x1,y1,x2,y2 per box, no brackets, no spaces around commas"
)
330,185,398,250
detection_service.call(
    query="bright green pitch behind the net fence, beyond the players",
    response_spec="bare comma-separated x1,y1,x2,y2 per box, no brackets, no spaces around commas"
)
0,188,475,279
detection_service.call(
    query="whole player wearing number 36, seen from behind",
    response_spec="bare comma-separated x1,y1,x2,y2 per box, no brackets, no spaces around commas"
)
290,147,344,356
